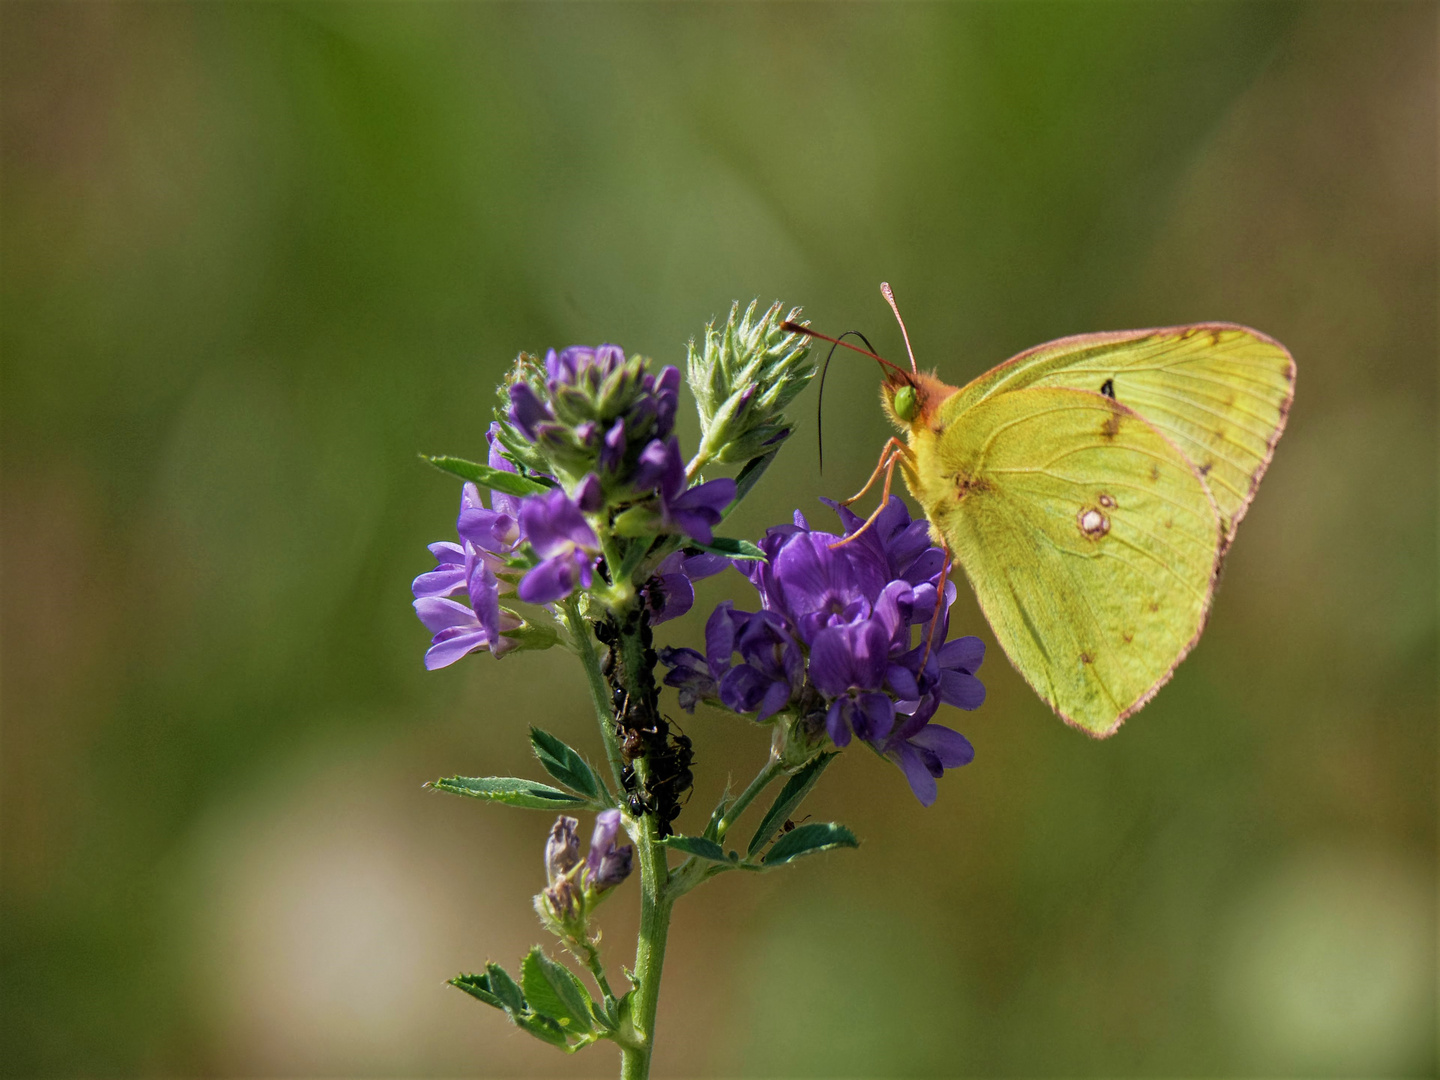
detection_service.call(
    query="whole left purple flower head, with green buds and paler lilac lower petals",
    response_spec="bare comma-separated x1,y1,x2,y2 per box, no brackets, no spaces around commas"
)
413,346,734,670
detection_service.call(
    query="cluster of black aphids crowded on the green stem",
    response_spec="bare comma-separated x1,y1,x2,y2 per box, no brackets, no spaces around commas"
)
595,603,694,837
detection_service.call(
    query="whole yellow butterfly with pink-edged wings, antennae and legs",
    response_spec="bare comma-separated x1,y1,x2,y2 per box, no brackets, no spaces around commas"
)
793,284,1295,739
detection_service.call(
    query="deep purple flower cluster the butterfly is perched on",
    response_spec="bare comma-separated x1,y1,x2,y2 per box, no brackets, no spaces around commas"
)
661,498,985,805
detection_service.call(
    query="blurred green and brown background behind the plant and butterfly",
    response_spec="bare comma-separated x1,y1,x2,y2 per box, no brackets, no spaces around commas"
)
0,3,1437,1077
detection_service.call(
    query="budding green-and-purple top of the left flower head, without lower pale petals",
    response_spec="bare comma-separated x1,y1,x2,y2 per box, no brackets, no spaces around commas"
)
505,346,734,544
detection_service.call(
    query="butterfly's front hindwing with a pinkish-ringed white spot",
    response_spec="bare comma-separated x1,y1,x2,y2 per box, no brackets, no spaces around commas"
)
907,386,1224,737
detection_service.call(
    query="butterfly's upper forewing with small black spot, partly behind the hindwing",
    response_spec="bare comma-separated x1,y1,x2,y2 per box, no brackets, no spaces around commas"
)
946,323,1295,546
